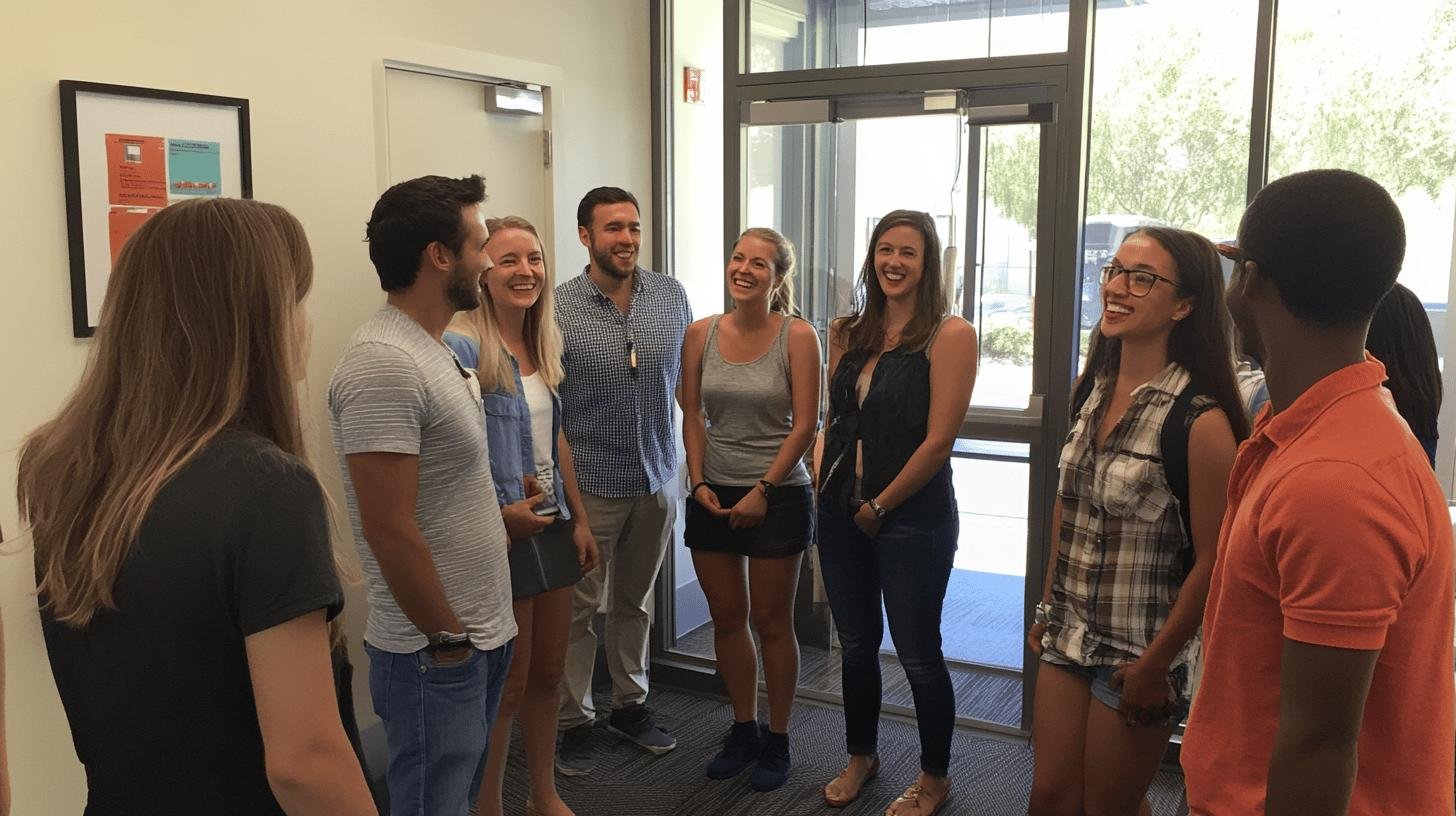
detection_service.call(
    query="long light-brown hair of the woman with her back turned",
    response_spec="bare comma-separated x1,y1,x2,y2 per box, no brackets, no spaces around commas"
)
16,198,313,628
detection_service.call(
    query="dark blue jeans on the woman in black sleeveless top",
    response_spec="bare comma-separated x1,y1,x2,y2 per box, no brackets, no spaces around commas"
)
820,507,961,777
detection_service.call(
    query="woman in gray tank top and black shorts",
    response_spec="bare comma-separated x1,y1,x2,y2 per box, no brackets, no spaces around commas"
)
683,227,821,791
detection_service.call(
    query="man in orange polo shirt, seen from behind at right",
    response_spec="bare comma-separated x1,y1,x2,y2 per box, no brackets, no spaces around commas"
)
1182,170,1456,816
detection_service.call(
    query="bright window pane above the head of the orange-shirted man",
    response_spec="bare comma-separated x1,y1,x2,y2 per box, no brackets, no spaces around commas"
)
1270,0,1456,357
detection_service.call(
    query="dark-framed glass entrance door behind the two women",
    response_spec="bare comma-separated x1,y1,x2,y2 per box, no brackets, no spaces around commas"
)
676,81,1075,730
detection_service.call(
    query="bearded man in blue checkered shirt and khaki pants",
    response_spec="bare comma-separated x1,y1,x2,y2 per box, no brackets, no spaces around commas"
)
556,187,693,775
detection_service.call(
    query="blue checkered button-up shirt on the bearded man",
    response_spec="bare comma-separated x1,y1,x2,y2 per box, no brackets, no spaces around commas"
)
556,267,693,498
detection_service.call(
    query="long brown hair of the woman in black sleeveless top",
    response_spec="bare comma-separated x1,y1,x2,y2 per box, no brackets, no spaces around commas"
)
839,210,951,351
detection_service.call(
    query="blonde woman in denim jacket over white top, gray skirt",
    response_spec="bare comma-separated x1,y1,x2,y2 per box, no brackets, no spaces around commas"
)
444,216,597,816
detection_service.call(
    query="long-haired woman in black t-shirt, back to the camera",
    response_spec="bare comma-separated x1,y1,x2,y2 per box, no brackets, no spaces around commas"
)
17,198,376,815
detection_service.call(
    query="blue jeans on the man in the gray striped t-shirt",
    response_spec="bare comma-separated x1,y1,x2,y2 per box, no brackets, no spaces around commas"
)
364,641,514,816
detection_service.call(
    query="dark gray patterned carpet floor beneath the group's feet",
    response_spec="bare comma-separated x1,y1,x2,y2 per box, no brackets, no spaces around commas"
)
505,688,1182,816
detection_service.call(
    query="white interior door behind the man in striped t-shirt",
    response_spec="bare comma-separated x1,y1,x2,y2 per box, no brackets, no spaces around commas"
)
384,68,552,237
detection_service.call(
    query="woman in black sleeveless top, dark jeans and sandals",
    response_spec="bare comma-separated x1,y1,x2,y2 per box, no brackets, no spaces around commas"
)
818,210,977,816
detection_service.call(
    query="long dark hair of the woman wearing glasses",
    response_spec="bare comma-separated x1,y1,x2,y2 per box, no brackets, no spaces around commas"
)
1072,227,1249,442
